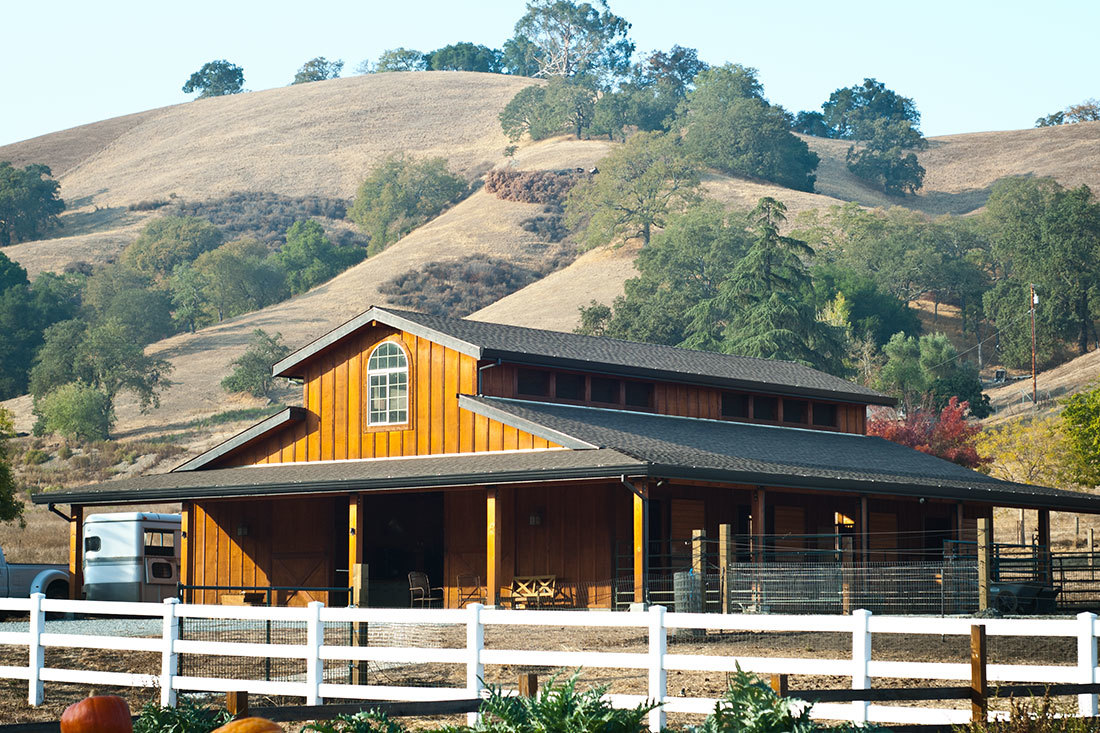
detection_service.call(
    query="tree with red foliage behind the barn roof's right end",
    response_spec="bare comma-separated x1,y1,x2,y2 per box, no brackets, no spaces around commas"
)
867,397,990,469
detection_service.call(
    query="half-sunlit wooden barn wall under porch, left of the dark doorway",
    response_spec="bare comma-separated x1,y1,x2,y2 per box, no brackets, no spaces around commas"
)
185,496,334,605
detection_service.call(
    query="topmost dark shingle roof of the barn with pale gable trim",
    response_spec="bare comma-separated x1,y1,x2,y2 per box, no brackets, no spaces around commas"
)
273,307,894,405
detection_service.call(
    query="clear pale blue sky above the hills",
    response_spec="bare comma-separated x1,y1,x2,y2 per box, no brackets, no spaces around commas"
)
0,0,1100,144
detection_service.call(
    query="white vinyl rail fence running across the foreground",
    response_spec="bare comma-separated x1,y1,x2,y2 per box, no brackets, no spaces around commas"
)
0,593,1097,731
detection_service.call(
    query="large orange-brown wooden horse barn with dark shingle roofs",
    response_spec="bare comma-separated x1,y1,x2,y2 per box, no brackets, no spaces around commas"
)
34,307,1100,613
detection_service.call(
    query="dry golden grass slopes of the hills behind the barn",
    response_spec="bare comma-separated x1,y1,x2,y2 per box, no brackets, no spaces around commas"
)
0,72,1100,451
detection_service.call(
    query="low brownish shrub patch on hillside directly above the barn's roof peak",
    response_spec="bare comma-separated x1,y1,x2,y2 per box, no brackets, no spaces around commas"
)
378,254,545,317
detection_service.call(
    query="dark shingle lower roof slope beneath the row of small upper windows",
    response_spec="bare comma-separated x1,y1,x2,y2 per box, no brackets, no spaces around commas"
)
460,396,1100,513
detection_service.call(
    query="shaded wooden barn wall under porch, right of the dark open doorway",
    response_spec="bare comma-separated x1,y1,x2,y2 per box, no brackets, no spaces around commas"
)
443,484,630,608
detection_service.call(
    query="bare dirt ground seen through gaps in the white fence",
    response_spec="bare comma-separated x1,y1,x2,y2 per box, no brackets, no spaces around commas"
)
0,626,1076,730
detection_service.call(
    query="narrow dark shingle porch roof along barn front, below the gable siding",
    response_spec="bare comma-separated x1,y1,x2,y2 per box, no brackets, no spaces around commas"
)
33,449,646,505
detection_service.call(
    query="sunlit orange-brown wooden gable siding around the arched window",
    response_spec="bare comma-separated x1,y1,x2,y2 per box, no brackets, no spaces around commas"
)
211,328,558,468
